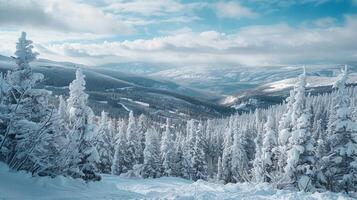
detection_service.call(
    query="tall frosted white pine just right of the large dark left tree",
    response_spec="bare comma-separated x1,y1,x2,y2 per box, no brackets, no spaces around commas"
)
67,69,100,181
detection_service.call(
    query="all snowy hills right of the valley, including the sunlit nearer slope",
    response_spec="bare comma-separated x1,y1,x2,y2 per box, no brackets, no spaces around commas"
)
150,63,357,111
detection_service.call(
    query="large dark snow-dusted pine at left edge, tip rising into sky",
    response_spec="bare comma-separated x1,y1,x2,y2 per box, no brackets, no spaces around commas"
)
0,32,55,174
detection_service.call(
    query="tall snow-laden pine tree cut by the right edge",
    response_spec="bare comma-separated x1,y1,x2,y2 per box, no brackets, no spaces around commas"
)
323,67,357,192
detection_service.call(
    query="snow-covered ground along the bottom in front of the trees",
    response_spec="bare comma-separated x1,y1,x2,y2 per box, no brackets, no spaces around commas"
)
0,163,353,200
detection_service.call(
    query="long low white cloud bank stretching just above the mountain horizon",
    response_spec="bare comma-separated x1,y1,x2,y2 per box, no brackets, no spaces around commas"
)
27,16,357,67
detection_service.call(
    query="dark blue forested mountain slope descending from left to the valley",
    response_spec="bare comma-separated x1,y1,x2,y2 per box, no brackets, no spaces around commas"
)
0,56,234,119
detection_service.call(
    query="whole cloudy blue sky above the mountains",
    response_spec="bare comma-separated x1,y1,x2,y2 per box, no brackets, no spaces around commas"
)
0,0,357,67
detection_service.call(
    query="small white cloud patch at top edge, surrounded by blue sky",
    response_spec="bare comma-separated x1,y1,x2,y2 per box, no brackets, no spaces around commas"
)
215,1,258,19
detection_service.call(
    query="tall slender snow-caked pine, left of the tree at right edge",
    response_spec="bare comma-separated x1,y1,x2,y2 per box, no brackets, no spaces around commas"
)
285,69,316,191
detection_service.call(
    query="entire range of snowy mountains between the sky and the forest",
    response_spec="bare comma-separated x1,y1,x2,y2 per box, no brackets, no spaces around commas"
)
0,56,357,119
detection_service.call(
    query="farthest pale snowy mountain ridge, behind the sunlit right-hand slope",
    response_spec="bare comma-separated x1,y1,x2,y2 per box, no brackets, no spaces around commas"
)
150,65,357,97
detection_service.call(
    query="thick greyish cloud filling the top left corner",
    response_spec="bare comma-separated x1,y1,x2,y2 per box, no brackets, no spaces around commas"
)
0,0,133,34
